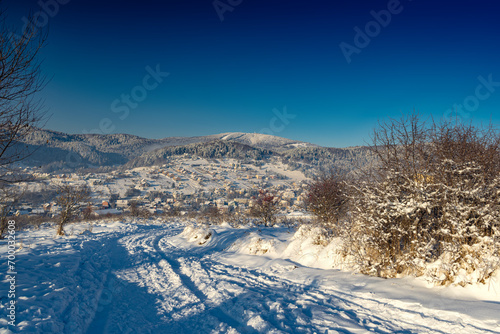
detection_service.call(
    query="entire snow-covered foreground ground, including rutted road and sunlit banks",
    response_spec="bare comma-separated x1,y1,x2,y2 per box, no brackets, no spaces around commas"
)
0,220,500,334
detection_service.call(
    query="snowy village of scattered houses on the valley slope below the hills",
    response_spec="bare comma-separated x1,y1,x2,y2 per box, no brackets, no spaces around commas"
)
10,155,308,218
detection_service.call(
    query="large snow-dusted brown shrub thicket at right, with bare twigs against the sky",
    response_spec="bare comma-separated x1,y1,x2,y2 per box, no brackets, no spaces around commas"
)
344,115,500,284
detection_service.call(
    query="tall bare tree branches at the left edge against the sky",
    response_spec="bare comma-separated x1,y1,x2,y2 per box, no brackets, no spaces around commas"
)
0,9,46,182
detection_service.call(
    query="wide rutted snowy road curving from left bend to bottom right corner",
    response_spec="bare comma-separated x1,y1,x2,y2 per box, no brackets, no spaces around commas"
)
84,223,499,333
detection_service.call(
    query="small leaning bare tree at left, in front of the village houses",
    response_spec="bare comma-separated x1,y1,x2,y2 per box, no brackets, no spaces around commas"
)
56,184,91,235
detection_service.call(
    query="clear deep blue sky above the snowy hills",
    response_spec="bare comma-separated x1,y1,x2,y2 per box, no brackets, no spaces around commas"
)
1,0,500,147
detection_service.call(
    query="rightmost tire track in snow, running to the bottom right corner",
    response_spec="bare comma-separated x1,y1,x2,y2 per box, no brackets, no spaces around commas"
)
204,264,488,334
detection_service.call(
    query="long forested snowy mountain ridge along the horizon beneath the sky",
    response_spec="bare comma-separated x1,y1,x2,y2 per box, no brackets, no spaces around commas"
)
14,129,372,171
